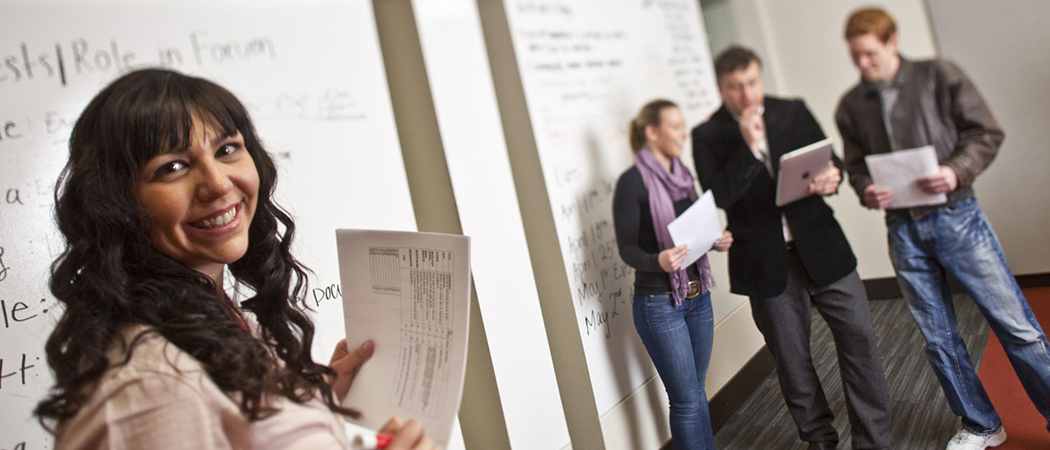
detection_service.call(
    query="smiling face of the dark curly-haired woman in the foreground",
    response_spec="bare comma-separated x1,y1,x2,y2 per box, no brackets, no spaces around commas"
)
135,115,259,281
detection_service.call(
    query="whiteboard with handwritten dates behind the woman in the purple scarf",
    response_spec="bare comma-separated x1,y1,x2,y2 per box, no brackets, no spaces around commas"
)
506,0,722,415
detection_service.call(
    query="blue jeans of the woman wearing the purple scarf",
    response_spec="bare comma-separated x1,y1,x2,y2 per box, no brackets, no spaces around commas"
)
633,293,715,450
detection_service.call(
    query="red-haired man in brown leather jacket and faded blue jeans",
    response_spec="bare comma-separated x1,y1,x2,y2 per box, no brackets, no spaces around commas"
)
836,8,1050,450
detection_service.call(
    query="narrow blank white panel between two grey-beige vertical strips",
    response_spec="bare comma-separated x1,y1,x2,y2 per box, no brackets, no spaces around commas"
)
413,0,569,450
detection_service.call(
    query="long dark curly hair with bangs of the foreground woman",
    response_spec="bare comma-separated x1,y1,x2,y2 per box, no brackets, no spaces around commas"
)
35,69,356,428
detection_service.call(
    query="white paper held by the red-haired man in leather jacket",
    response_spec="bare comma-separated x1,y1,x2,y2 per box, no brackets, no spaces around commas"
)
864,146,948,209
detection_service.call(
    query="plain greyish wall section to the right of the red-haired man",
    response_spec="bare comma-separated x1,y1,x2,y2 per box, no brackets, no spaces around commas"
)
927,0,1050,275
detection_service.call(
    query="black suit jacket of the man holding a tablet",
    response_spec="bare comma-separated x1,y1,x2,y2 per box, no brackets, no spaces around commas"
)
693,97,857,297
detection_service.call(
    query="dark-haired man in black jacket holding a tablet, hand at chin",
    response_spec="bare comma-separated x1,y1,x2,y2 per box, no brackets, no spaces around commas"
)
693,47,890,449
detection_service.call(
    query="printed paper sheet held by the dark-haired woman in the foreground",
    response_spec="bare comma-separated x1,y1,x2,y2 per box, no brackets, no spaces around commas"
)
336,230,470,447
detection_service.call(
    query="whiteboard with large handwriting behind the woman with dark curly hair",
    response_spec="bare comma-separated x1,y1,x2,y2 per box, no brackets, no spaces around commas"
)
0,0,416,449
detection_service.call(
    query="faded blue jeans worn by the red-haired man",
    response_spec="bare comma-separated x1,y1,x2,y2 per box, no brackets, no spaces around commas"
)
886,197,1050,434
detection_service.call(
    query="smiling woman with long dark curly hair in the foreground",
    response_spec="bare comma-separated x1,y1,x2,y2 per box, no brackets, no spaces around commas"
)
36,69,433,449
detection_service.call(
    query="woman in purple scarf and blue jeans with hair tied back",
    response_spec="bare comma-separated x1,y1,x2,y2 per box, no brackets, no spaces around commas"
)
609,100,733,450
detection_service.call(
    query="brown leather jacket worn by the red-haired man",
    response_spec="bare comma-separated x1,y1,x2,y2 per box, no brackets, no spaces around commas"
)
835,58,1003,218
